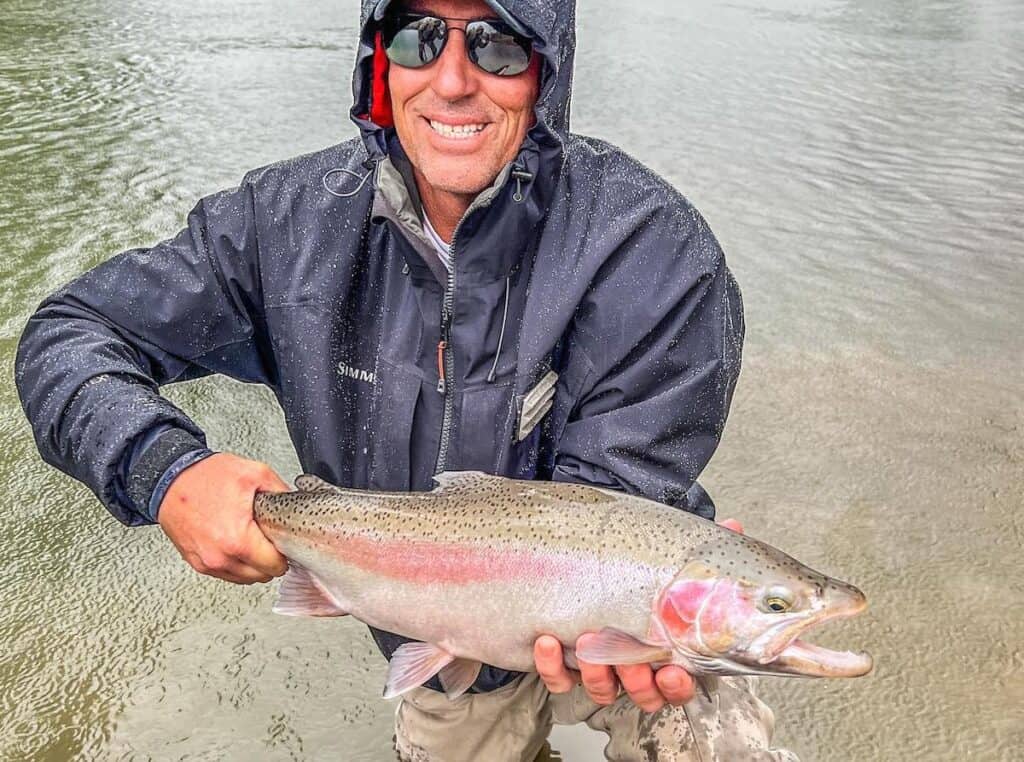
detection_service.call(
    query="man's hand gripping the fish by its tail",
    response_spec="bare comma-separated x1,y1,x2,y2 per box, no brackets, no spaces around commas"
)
158,453,289,585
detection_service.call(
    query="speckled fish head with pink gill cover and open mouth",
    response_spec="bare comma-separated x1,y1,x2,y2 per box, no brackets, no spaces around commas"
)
654,530,871,677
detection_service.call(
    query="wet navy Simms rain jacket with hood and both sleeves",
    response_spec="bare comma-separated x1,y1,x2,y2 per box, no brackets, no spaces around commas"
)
15,0,743,690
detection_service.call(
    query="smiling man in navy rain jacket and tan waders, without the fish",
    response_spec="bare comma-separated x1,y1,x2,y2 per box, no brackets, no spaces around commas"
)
16,0,792,760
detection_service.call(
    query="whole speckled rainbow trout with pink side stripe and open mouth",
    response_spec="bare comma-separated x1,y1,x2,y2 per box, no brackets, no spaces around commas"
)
254,471,872,699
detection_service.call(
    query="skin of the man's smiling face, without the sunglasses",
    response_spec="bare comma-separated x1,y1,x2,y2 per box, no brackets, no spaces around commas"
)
388,0,539,196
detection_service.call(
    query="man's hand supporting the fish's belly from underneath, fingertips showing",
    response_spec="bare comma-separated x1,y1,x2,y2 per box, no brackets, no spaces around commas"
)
534,518,743,712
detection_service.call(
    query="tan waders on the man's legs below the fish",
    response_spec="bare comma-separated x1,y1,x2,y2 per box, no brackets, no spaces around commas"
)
395,673,799,762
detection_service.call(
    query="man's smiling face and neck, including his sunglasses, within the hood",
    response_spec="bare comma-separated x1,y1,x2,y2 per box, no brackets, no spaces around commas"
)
382,0,541,241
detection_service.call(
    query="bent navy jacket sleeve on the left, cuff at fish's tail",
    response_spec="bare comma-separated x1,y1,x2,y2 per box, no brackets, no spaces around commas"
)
15,177,273,524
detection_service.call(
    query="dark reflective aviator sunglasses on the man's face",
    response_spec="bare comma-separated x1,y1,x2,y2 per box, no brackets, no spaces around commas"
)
383,13,534,77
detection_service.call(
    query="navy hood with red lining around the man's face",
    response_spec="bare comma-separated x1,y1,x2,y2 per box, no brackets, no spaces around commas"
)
350,0,575,160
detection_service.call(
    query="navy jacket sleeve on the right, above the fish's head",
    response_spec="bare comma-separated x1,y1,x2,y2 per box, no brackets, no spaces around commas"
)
553,210,743,518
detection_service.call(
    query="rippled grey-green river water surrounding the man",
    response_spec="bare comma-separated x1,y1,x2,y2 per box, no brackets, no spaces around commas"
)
0,0,1024,761
